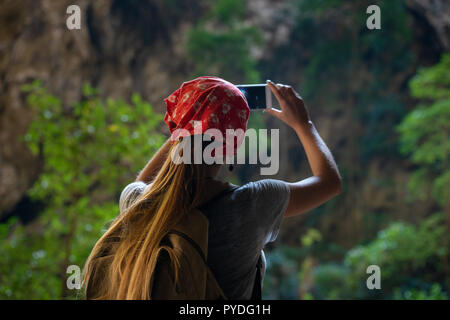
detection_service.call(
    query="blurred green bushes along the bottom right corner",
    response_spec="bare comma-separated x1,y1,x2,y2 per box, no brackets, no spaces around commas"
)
263,214,448,300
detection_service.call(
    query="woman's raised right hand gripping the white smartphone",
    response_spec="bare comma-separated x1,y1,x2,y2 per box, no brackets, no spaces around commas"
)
265,80,310,130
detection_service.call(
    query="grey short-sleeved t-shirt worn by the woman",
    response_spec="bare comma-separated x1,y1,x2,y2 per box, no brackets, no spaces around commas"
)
119,179,290,299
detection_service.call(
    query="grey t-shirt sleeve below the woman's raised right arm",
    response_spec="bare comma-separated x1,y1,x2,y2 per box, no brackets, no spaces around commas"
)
248,179,290,245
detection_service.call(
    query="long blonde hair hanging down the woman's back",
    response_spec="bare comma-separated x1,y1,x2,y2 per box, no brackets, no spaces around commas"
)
83,141,209,299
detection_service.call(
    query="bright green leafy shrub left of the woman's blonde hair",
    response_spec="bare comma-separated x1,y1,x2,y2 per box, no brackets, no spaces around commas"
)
0,81,164,299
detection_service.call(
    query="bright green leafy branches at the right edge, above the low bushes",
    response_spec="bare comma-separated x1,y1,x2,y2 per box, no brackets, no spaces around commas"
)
397,54,450,206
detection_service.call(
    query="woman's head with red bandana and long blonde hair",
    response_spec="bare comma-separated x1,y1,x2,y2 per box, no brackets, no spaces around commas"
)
84,77,250,299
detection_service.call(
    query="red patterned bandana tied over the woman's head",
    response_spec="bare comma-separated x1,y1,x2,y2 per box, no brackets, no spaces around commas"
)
164,76,250,155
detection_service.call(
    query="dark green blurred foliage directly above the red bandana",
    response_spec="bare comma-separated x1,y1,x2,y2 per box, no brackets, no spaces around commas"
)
186,0,262,82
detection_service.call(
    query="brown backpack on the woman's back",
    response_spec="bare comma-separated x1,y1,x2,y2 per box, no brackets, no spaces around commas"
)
150,187,262,300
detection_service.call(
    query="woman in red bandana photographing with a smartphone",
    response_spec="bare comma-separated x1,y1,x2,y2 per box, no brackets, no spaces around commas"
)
85,77,341,299
